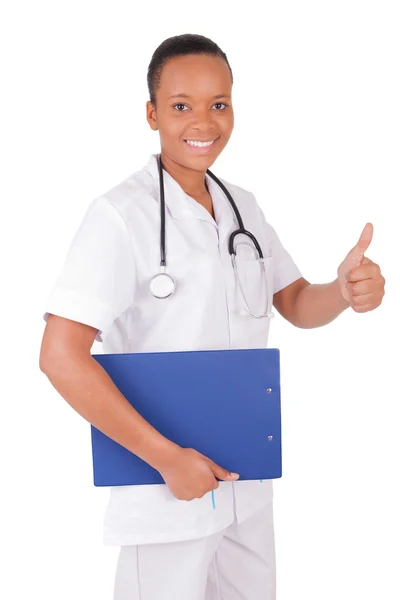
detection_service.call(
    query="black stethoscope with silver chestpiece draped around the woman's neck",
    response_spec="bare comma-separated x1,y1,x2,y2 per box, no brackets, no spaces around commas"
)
150,154,274,319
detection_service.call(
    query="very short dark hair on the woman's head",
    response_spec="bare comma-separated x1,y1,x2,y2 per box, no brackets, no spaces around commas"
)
147,33,233,104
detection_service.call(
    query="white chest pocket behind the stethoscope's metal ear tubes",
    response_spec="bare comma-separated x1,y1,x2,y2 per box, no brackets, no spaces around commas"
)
235,240,273,321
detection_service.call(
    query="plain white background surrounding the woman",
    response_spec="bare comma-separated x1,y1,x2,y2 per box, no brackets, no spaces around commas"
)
0,0,400,600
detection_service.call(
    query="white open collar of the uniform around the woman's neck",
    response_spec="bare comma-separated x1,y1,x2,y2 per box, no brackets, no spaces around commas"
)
146,154,238,243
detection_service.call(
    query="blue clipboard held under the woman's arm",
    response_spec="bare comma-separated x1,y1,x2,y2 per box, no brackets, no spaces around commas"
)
91,348,282,486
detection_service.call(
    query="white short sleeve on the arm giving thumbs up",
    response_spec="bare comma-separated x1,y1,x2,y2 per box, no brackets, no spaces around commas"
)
258,206,302,294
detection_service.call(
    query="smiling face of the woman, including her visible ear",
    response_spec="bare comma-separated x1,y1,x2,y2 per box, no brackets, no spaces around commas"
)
146,54,234,171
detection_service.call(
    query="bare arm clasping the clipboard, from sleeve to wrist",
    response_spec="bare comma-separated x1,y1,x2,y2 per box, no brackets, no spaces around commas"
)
39,314,181,471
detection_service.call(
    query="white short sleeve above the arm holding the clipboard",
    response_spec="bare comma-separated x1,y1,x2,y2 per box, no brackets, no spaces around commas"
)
43,196,135,342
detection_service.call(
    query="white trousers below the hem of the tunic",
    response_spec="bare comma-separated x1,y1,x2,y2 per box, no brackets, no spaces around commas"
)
114,501,276,600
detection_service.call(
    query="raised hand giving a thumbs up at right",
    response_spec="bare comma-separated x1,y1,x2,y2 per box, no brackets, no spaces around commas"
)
337,223,386,312
